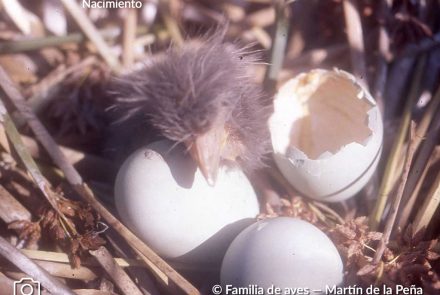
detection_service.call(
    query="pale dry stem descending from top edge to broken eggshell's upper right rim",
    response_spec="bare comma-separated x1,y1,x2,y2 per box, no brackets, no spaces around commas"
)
342,0,368,89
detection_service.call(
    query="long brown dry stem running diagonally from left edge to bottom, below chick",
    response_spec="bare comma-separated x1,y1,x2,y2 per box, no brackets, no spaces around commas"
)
0,63,199,294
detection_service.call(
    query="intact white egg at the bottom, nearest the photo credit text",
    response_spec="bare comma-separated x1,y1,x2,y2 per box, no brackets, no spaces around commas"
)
220,217,343,294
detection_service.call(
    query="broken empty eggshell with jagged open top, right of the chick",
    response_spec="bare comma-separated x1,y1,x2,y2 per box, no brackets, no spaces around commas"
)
269,69,383,202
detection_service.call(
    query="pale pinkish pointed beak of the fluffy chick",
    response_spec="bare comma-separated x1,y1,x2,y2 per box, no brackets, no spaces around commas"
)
188,124,225,186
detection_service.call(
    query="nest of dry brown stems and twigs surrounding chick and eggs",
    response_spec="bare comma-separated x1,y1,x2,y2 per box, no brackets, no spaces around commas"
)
0,0,440,295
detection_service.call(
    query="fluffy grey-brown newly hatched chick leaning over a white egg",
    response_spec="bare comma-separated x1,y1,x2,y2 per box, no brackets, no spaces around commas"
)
108,30,271,185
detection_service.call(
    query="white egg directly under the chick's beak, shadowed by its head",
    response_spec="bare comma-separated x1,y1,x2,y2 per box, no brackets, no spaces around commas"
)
115,141,259,264
